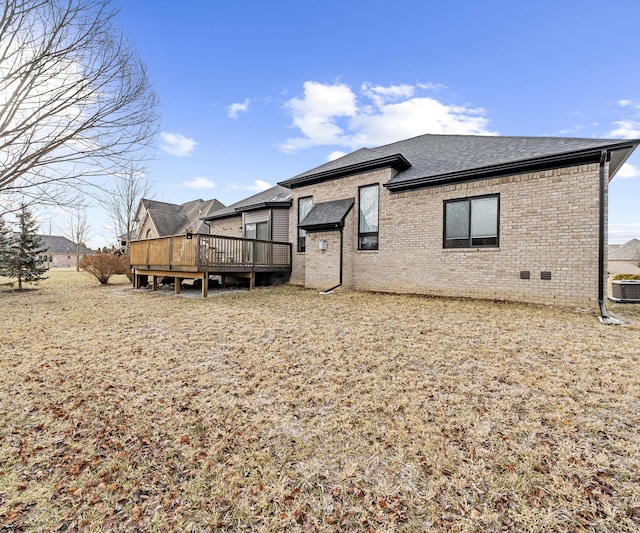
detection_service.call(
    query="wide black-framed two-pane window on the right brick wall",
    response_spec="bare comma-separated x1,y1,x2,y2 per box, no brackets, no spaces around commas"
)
442,194,500,248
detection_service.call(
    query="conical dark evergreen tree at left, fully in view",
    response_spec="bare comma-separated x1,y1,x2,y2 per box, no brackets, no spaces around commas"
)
5,205,47,290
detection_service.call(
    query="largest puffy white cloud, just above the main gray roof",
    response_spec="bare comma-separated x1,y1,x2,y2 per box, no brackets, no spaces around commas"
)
280,81,496,152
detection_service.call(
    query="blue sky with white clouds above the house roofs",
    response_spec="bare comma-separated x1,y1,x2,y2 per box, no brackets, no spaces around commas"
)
69,0,640,245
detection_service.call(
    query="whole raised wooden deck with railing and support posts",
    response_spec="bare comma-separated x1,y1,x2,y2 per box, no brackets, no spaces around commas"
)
129,233,291,298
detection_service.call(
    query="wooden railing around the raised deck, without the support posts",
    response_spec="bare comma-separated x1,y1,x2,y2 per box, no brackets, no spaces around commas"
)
129,233,291,272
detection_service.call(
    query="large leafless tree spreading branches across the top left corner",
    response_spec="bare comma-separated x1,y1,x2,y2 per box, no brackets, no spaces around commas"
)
0,0,158,205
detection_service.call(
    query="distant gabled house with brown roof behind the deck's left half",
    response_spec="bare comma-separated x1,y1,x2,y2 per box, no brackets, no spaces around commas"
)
132,198,224,240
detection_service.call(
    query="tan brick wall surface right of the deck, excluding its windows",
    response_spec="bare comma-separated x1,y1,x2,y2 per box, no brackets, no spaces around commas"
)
289,164,606,306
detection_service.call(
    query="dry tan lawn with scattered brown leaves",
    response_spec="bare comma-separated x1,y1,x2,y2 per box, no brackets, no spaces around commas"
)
0,271,640,532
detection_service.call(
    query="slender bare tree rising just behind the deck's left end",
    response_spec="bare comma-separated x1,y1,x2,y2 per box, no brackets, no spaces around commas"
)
103,167,151,247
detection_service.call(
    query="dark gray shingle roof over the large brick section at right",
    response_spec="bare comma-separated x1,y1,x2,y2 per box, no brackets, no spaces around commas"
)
280,134,640,191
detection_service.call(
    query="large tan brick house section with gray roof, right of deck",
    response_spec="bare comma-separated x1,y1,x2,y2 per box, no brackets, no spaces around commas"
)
280,135,640,308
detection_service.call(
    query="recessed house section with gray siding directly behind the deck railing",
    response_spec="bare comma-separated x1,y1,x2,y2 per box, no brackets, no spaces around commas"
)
203,185,291,242
